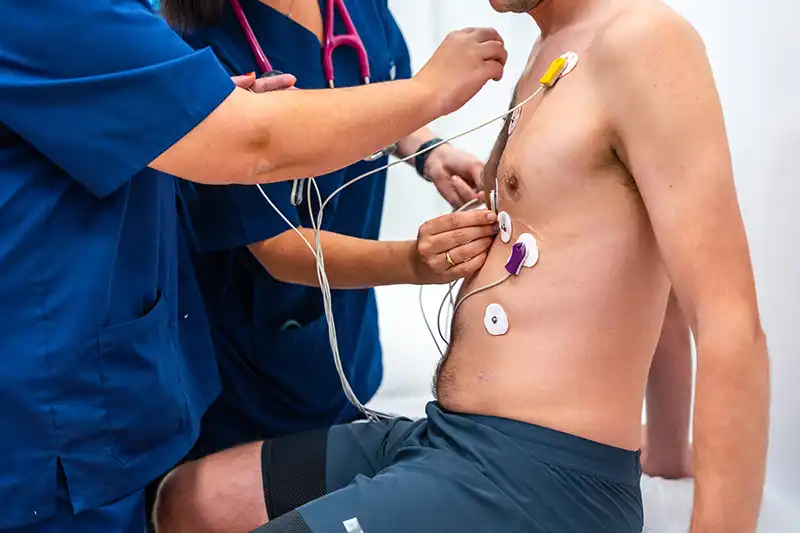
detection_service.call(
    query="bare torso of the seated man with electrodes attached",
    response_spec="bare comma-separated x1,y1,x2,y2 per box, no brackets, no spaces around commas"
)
444,2,688,449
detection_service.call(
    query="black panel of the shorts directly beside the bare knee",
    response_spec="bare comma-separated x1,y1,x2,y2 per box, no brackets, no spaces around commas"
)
259,429,328,520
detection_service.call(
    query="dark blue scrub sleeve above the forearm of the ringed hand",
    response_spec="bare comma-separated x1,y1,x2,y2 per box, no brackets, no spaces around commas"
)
178,180,304,253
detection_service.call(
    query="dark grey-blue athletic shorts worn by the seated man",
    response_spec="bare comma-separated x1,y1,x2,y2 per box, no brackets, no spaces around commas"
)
253,403,643,533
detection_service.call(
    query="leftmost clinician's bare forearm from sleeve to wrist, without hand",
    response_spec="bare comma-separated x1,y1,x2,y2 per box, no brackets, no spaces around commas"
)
150,80,441,185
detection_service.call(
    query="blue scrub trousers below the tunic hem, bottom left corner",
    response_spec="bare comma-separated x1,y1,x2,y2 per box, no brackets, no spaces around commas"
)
0,472,146,533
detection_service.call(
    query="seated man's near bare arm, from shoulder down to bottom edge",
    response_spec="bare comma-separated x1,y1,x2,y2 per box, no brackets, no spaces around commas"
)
604,6,769,533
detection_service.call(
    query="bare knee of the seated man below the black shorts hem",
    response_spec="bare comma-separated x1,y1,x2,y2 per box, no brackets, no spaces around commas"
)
154,443,267,533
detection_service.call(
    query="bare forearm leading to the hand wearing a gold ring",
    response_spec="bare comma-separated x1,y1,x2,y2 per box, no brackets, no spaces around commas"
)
249,228,416,289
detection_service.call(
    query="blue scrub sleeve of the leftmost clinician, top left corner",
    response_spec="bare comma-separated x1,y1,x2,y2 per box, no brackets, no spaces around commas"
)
0,0,233,197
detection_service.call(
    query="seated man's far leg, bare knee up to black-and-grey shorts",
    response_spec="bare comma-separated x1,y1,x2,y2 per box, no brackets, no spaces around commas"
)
155,420,413,533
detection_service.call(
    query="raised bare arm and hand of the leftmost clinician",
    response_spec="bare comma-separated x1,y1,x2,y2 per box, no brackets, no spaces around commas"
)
150,29,506,184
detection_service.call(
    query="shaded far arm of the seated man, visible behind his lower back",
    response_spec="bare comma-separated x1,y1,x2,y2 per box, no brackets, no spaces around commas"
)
642,293,692,479
